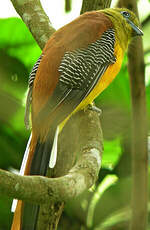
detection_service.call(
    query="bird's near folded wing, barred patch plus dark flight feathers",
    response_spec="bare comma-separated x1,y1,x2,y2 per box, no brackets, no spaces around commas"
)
36,28,116,125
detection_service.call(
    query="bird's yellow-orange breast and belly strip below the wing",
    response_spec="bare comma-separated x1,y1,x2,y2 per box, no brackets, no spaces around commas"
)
60,42,123,131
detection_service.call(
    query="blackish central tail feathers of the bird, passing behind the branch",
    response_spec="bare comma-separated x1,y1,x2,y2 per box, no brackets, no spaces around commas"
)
22,129,55,230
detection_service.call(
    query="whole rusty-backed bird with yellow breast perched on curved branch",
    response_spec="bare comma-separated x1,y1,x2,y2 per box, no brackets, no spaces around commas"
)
11,8,143,230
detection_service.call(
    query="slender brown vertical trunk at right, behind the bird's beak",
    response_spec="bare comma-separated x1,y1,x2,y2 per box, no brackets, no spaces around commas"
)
120,0,148,230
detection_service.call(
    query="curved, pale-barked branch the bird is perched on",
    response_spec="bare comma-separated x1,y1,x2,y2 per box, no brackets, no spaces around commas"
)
0,111,102,204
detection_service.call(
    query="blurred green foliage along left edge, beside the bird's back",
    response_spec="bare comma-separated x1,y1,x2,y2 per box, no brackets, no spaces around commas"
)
0,18,41,230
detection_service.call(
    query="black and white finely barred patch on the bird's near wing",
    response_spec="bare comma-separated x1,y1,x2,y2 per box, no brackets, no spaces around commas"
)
59,29,116,93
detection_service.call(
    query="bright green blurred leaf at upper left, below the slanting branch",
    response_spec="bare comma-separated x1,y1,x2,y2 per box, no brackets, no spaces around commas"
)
0,18,41,68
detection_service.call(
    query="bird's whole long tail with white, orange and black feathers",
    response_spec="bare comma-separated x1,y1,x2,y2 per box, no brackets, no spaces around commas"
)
11,127,59,230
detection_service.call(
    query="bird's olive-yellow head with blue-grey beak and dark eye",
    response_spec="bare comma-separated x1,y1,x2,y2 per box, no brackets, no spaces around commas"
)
101,8,143,48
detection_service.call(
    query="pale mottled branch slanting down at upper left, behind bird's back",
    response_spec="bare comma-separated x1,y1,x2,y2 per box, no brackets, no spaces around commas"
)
11,0,55,49
